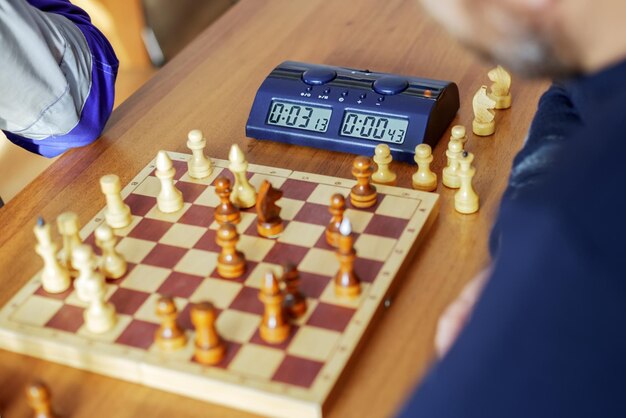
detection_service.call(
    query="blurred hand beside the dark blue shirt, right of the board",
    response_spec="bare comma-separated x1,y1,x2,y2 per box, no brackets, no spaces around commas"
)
435,267,491,358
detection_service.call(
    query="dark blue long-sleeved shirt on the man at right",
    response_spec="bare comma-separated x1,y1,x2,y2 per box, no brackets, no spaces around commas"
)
401,59,626,418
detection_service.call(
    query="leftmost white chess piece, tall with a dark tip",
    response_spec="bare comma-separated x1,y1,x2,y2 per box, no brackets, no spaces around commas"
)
33,217,71,293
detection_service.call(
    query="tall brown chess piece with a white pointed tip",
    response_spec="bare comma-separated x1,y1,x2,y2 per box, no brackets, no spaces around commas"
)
335,218,361,298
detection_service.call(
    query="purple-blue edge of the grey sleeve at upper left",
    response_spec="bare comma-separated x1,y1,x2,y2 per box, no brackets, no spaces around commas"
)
5,0,118,157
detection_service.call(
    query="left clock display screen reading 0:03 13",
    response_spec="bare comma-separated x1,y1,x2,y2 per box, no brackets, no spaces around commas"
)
267,100,333,132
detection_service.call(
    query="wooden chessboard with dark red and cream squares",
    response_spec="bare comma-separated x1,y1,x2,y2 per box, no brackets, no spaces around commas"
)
0,152,438,418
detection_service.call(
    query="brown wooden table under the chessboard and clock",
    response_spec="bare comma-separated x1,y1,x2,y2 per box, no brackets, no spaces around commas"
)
0,0,545,418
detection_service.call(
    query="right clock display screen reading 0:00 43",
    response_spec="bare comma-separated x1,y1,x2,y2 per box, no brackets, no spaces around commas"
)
340,110,409,144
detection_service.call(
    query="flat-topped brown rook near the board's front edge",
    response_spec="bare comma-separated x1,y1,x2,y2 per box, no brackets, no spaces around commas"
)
191,302,226,366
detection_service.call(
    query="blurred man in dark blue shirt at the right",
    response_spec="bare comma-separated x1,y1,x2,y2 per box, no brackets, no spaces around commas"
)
400,0,626,418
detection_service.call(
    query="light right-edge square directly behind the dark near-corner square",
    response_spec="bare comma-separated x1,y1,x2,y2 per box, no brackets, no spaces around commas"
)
287,325,341,362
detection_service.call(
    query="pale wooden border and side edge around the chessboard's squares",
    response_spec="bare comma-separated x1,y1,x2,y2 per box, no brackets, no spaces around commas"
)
0,152,439,418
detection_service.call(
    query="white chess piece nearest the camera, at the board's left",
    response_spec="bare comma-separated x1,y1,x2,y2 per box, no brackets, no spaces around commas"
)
82,260,117,334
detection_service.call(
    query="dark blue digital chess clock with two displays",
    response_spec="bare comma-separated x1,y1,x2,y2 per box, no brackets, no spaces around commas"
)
246,61,459,162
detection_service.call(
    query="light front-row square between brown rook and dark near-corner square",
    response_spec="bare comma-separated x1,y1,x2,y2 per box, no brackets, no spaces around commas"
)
228,344,285,379
